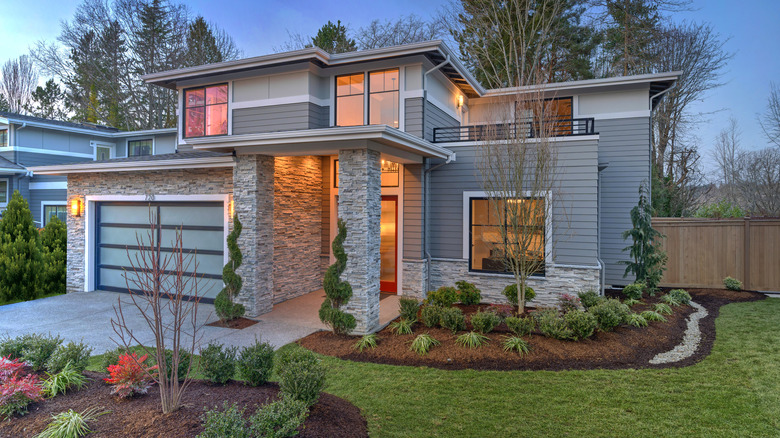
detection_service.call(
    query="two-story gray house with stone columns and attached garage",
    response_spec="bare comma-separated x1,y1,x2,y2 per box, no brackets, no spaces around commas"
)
32,41,678,333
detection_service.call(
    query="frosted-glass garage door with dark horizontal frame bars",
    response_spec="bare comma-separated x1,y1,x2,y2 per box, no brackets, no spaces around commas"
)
95,202,225,302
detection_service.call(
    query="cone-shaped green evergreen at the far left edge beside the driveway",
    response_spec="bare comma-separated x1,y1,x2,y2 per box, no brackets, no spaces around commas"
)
0,190,43,301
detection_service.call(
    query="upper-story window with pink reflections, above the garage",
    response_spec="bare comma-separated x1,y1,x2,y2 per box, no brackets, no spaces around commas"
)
184,84,228,138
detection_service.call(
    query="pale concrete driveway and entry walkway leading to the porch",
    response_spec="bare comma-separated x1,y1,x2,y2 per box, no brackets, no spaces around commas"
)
0,290,398,354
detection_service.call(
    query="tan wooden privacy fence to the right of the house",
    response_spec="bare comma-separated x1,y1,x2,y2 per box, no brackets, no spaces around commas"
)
653,218,780,291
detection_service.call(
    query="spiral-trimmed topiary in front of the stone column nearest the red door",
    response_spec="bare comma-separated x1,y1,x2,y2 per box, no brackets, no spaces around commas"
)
319,219,357,335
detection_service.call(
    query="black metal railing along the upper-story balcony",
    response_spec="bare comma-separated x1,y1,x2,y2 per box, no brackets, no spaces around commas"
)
433,117,595,143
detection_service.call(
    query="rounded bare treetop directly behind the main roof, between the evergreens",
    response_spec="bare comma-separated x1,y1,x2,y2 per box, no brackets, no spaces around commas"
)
355,14,447,50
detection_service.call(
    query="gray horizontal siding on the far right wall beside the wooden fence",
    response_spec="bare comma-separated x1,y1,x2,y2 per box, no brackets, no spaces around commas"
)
596,117,650,285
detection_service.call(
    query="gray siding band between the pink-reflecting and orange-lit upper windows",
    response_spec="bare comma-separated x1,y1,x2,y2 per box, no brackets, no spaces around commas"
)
233,102,330,135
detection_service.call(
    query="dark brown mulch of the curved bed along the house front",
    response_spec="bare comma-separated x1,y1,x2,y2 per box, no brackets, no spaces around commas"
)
298,289,764,371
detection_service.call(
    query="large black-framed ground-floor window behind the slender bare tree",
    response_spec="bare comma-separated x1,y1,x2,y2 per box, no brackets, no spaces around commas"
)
469,197,546,275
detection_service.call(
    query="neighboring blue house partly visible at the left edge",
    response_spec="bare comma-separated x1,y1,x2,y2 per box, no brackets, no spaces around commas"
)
0,111,176,227
